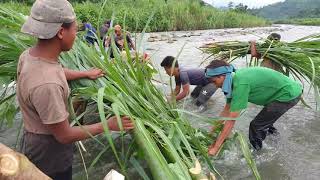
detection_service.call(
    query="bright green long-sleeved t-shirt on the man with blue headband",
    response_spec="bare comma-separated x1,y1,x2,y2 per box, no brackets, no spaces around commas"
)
227,67,302,112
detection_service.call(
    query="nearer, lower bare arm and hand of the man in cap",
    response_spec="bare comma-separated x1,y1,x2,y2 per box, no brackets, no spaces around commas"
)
46,116,134,144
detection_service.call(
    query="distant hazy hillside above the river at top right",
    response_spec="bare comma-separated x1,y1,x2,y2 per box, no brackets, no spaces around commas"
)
253,0,320,25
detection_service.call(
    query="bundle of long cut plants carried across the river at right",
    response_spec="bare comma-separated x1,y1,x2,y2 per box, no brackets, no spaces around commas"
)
201,34,320,107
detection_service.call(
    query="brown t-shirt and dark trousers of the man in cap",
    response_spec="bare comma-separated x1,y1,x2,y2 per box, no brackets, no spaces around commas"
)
17,49,73,175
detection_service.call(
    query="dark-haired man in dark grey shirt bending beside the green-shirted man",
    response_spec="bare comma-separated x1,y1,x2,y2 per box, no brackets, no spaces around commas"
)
161,56,217,112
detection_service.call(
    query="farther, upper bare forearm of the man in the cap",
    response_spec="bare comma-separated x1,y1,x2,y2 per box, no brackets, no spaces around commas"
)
63,68,104,81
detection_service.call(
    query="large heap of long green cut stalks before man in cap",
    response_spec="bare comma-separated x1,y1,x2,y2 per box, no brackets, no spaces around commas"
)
0,8,260,180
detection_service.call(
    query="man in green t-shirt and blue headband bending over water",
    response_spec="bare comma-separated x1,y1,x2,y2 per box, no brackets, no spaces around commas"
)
206,60,302,155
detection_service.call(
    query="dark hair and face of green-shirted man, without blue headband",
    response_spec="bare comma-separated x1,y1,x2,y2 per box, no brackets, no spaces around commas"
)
206,60,229,88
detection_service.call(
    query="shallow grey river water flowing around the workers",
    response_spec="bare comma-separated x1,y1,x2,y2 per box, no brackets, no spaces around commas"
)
0,25,320,180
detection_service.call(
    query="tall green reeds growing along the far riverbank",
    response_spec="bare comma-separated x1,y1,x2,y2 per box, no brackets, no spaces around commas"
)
1,0,268,31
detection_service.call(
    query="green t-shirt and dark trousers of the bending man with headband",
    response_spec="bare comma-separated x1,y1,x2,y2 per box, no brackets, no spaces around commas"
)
227,67,302,150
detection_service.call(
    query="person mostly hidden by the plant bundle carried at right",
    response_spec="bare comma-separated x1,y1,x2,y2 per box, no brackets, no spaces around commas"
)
250,33,283,73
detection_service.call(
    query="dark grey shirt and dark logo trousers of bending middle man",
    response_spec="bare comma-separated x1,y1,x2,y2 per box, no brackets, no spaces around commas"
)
175,67,217,106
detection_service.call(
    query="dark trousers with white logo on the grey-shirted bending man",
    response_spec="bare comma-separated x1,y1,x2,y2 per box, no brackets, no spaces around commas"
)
191,83,217,106
